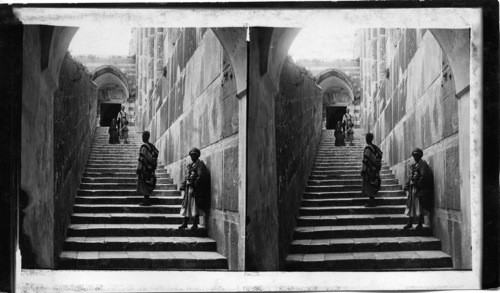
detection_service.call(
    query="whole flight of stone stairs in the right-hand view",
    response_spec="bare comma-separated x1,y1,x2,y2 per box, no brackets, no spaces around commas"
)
285,130,452,271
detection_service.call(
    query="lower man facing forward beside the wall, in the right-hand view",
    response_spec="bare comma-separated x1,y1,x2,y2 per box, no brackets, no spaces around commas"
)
403,148,434,230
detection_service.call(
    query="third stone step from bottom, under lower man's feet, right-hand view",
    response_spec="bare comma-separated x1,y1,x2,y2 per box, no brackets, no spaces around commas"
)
294,224,432,239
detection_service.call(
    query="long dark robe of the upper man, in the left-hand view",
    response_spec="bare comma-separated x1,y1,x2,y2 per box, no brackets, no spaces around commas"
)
137,143,158,196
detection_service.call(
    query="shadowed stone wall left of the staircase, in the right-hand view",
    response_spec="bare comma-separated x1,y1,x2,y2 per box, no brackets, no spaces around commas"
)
275,58,323,268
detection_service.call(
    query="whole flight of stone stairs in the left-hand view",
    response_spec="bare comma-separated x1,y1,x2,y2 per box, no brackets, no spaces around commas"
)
59,127,228,270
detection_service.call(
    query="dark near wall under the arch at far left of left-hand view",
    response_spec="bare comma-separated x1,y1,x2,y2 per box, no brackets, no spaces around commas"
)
19,26,55,268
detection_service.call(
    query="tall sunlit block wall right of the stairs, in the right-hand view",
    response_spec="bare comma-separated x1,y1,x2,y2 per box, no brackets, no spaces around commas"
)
358,29,471,269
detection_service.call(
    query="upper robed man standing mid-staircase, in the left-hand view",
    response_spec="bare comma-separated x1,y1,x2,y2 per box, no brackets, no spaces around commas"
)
136,131,159,206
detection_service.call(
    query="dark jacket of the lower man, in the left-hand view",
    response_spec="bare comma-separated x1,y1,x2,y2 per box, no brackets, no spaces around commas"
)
180,160,211,212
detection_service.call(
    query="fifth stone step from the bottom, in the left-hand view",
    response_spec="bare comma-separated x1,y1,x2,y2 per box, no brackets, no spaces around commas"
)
73,203,181,214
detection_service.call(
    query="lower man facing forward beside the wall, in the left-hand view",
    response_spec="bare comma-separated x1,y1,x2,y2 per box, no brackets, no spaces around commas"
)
179,148,210,230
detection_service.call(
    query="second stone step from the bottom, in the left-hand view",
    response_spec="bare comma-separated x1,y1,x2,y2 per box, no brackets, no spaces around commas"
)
64,236,217,251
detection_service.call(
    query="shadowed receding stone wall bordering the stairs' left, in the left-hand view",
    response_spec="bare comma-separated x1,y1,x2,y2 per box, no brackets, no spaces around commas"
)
53,54,97,266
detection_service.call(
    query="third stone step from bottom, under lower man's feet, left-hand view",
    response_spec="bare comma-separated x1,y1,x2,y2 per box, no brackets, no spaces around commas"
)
68,224,207,237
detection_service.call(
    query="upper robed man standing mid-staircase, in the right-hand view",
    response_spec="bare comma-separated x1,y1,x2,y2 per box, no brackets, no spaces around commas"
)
361,133,383,207
